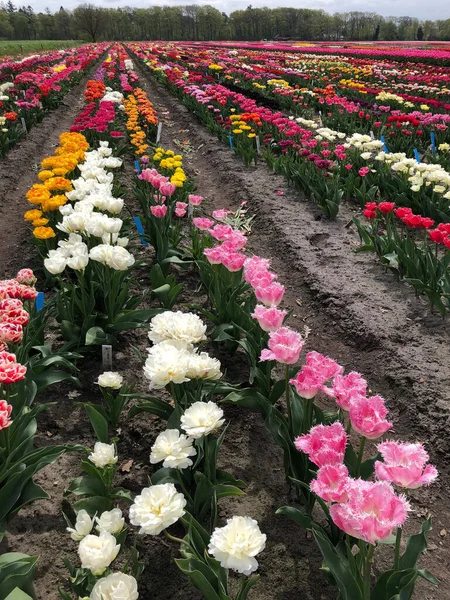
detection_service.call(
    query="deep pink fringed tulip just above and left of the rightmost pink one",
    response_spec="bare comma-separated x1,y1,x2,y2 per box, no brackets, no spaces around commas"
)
350,395,392,440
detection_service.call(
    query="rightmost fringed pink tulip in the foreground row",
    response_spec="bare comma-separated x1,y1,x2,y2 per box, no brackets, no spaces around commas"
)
375,441,438,489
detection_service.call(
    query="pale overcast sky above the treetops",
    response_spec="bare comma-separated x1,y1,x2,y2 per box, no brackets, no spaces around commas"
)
20,0,450,20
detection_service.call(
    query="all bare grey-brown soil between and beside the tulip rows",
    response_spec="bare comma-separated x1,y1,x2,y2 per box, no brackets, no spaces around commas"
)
0,57,450,600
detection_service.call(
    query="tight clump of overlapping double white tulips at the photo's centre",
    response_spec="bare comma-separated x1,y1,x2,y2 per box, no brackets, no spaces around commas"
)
144,311,222,389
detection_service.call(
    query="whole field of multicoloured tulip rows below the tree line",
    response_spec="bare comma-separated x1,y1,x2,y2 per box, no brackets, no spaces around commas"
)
0,42,450,600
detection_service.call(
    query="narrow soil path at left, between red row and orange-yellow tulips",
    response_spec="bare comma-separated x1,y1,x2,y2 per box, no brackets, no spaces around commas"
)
0,59,107,278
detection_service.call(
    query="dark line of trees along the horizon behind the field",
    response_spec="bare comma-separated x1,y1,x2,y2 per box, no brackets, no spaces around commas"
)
0,0,450,42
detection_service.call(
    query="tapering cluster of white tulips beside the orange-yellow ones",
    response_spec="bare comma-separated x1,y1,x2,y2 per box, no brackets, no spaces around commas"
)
44,142,134,275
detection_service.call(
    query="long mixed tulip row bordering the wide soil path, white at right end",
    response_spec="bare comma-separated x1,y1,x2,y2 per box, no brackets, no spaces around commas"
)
125,44,450,221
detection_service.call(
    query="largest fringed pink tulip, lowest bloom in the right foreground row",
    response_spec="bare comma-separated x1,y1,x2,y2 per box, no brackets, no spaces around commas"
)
330,479,410,545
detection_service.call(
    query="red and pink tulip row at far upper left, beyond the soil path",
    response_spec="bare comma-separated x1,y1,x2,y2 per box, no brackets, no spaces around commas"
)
0,43,108,158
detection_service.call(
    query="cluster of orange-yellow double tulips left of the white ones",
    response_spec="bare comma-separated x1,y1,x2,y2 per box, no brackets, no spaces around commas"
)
24,132,89,240
